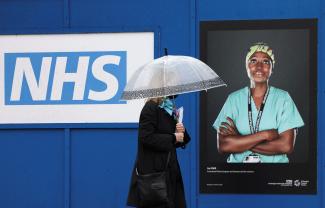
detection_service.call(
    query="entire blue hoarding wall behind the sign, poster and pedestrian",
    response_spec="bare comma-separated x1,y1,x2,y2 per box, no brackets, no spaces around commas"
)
0,0,325,208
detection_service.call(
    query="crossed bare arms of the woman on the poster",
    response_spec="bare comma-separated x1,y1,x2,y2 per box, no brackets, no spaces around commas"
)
218,117,294,155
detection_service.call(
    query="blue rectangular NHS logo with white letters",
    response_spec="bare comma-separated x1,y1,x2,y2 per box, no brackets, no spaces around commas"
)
4,51,127,105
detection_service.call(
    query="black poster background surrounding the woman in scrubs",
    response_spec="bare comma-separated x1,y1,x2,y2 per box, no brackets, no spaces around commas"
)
200,19,317,194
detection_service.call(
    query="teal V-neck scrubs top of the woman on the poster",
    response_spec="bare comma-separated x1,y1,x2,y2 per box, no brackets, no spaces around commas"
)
213,87,304,163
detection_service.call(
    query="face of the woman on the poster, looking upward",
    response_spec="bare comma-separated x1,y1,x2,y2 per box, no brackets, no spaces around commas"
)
248,52,272,84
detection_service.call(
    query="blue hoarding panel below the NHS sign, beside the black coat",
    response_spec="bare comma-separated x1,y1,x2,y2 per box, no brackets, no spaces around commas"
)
71,129,137,208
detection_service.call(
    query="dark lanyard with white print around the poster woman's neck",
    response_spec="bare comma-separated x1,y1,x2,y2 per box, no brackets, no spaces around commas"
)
248,87,270,134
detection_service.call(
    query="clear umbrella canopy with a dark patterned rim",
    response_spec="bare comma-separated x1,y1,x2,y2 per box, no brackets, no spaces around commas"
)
121,55,226,100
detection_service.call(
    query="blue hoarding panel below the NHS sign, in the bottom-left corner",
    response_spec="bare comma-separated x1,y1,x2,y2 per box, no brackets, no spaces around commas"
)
0,129,64,208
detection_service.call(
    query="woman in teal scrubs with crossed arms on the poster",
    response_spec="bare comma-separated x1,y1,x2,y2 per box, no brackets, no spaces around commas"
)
213,42,304,163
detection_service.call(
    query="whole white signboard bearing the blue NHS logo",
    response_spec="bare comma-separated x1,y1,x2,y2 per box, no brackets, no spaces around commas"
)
0,32,155,125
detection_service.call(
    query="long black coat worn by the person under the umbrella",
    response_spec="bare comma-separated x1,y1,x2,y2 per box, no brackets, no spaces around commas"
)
127,101,190,208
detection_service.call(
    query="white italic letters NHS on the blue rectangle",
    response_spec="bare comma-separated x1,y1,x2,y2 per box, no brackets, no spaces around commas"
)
10,55,121,101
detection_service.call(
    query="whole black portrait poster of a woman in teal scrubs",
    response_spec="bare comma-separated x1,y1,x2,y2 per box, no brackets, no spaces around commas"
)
200,19,317,194
